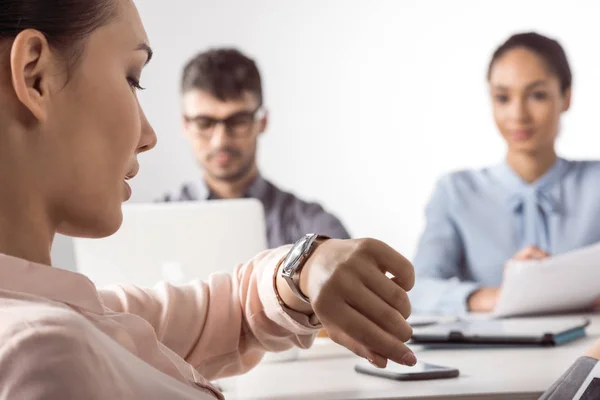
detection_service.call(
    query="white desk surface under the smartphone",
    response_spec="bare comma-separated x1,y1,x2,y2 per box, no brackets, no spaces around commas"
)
221,314,600,400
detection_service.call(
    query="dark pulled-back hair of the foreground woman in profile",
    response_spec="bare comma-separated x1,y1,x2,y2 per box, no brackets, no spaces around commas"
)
0,0,117,67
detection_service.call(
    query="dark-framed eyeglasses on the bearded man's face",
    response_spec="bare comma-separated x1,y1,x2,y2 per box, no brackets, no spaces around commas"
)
184,105,266,140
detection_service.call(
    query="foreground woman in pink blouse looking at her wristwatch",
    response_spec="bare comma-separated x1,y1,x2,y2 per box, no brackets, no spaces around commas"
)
0,0,416,400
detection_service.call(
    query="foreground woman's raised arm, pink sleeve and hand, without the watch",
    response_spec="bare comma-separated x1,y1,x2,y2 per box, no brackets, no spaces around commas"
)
101,239,416,379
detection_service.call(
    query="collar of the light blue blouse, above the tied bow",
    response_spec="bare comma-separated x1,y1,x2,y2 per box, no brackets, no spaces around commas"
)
490,158,569,213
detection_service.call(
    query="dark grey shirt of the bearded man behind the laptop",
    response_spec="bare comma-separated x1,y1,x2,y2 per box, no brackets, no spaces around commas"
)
161,176,350,248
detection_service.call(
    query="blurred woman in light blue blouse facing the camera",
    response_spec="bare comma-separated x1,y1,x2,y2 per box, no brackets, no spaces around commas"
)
411,33,600,314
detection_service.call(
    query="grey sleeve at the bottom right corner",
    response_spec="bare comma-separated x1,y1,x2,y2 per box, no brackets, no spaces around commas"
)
540,357,600,400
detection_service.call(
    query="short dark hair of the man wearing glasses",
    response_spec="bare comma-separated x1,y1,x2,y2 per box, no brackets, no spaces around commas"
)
181,49,263,104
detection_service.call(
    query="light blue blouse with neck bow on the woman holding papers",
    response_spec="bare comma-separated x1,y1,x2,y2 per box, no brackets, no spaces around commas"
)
409,159,600,314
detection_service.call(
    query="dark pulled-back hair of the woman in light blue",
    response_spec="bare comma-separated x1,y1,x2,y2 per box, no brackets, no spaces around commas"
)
488,32,573,93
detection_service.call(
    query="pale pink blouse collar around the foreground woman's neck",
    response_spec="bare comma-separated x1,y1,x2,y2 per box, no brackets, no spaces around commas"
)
0,254,104,314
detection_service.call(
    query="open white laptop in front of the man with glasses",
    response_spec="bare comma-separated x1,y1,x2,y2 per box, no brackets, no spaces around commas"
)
74,199,267,288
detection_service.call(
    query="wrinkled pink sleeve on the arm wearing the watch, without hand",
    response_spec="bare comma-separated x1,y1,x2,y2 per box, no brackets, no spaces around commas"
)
100,247,320,379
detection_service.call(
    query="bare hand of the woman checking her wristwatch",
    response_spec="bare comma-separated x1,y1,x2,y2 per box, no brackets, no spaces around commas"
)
300,239,416,367
